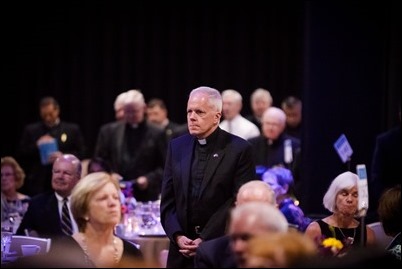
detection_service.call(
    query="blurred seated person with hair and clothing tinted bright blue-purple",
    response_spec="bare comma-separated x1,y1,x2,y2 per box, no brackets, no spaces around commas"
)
262,166,311,231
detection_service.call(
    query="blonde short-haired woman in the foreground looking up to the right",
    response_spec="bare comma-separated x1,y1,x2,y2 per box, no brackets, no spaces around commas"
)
49,172,143,267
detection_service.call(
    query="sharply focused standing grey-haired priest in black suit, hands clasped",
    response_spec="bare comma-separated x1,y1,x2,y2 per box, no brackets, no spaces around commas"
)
161,87,256,268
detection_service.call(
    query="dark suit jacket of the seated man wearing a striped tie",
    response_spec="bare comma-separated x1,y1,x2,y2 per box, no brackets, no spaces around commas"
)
16,191,65,238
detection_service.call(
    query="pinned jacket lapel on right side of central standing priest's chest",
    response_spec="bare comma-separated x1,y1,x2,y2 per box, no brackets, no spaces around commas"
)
200,131,225,197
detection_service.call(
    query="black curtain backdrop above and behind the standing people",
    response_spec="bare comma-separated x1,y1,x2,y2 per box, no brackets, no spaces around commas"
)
1,1,401,214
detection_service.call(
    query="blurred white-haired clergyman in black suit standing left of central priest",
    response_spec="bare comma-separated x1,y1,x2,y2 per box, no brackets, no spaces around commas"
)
95,90,166,201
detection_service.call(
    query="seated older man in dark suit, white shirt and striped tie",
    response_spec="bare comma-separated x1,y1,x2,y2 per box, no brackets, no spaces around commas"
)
16,154,81,238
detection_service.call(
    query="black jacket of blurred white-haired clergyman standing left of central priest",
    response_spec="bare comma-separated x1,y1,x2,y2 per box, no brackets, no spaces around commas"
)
95,121,166,201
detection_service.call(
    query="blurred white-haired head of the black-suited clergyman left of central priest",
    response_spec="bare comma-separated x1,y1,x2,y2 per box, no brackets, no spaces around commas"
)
124,89,146,124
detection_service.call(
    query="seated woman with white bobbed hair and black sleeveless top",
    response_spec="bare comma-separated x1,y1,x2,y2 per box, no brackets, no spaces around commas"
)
305,172,375,256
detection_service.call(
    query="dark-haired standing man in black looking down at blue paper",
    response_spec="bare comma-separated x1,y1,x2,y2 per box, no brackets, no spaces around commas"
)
17,97,86,196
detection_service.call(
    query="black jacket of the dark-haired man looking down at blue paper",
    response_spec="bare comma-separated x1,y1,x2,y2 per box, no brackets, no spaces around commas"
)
17,121,86,196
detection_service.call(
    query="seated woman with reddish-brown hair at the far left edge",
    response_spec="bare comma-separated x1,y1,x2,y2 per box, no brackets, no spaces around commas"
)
1,156,30,221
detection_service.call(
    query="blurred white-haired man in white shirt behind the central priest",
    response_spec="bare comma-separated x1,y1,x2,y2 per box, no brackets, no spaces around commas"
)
219,89,260,140
